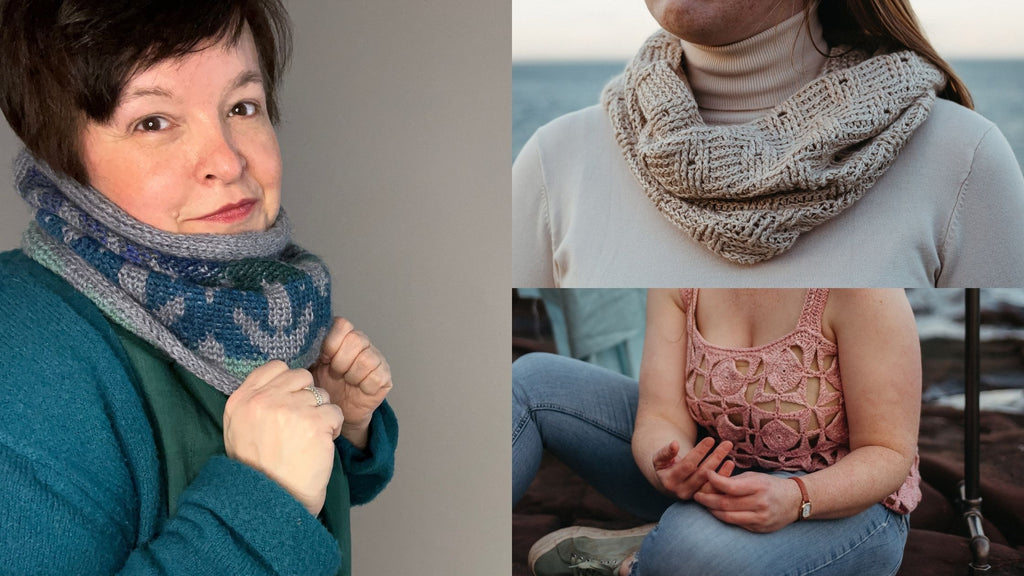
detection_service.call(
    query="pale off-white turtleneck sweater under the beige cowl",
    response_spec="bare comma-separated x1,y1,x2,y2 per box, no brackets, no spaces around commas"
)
512,16,1024,287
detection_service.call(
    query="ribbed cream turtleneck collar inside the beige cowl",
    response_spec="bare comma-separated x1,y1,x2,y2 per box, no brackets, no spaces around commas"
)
681,5,827,124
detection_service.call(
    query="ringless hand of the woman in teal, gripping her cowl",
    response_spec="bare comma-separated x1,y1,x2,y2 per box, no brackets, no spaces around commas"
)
310,318,391,449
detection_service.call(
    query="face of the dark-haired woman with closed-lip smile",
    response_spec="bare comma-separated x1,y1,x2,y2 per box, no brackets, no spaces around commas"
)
81,30,281,234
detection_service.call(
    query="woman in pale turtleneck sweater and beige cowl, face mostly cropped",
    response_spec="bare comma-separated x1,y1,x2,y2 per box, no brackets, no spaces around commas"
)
512,0,1024,287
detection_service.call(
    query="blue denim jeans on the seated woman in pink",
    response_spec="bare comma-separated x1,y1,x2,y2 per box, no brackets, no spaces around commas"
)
512,354,909,576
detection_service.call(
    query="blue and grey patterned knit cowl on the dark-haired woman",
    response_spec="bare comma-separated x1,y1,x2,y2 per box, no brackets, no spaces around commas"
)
14,147,331,394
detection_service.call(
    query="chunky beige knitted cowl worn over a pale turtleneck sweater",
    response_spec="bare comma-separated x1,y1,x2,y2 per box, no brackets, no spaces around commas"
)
601,31,945,264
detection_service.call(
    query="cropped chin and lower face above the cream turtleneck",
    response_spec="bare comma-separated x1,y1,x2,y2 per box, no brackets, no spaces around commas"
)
645,0,807,46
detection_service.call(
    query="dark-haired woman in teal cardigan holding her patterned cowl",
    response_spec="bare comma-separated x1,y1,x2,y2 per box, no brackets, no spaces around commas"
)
0,0,397,574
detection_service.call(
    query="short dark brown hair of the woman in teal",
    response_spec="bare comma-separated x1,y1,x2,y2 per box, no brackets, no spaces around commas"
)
0,0,292,183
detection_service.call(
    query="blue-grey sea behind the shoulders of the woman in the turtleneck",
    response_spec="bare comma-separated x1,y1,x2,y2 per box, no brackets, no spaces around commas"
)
512,60,1024,165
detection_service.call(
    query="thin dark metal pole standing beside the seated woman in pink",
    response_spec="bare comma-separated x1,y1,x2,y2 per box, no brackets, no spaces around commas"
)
959,288,991,574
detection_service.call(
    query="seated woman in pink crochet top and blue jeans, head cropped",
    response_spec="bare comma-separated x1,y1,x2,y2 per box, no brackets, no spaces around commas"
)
513,289,921,576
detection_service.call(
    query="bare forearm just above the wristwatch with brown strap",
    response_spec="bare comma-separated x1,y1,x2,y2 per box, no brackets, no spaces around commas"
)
794,446,914,519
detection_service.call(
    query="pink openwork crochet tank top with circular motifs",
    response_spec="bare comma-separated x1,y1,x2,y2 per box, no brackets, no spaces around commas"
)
681,289,921,513
